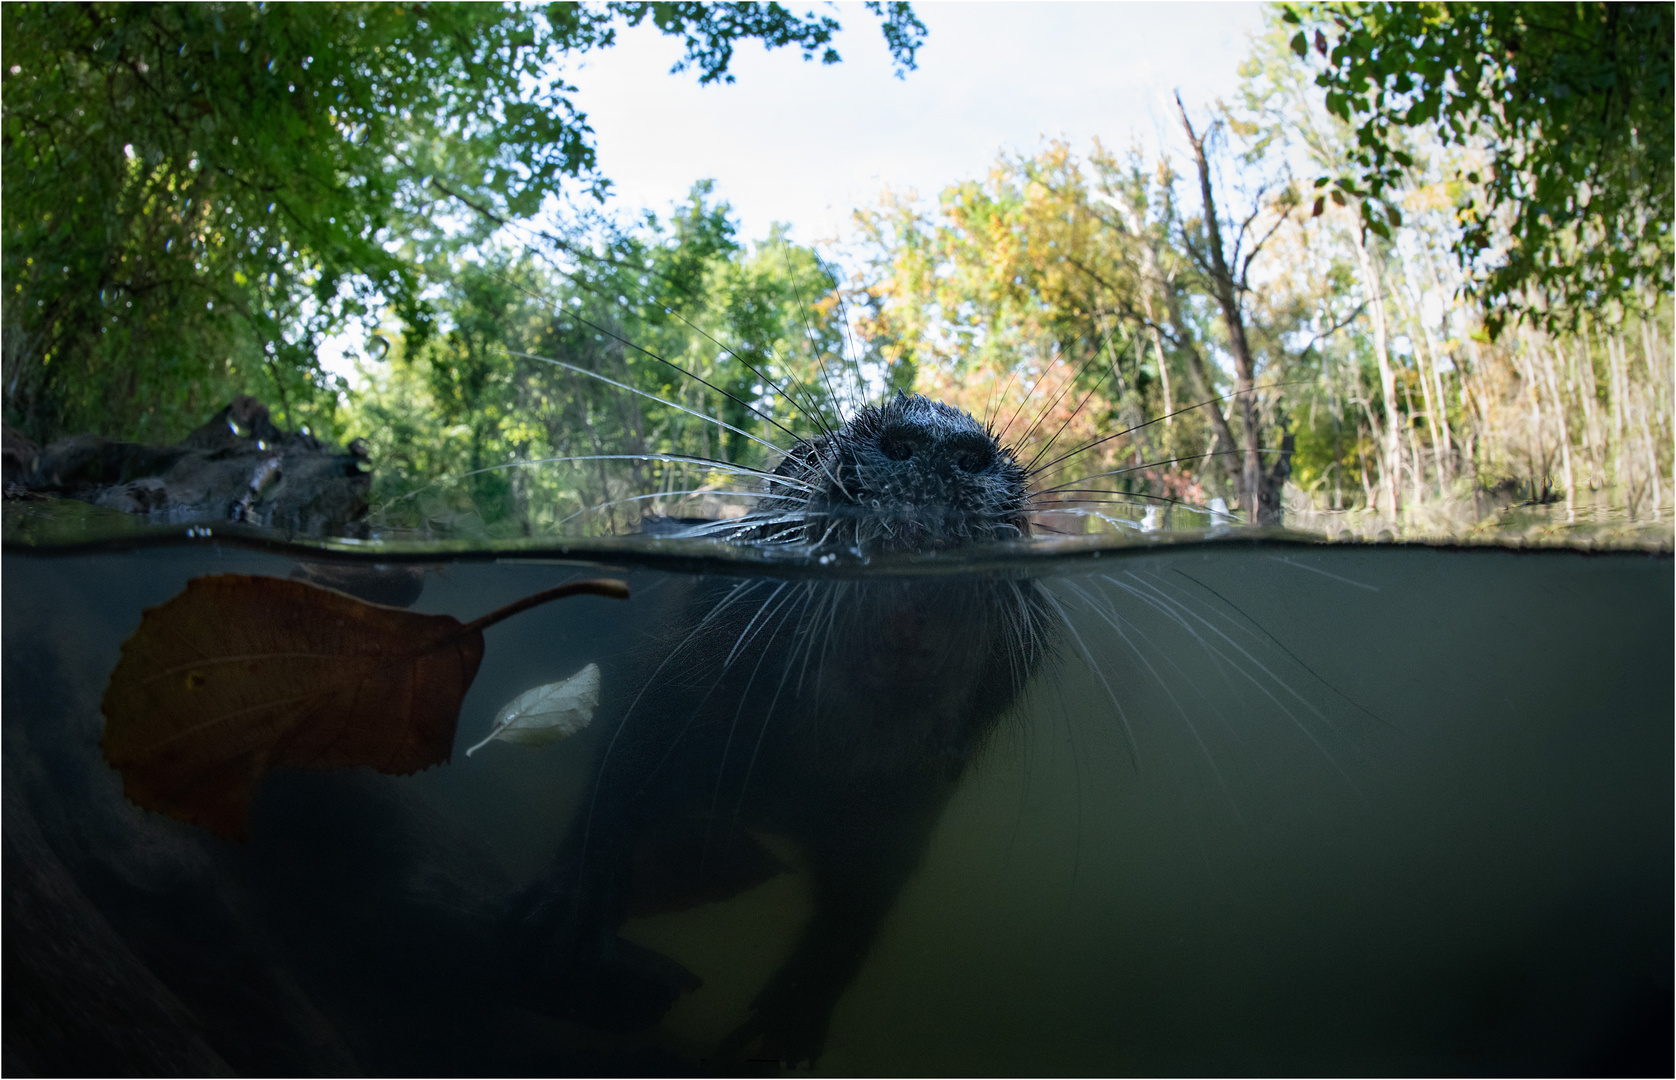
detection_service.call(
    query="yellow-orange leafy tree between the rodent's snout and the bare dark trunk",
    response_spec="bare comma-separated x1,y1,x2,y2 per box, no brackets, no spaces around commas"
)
856,143,1246,523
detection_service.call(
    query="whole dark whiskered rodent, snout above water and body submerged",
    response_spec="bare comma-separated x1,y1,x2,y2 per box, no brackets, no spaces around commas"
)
511,394,1051,1063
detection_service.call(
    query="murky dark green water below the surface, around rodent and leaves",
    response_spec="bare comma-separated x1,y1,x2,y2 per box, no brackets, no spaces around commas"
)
3,523,1676,1075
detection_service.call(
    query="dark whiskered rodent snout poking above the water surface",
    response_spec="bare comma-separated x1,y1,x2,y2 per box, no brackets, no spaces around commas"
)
764,394,1029,553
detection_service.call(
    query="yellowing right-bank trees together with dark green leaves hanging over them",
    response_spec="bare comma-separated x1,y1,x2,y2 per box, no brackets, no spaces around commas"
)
860,5,1673,527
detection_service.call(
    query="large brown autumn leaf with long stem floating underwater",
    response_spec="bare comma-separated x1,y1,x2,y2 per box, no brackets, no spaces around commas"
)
101,574,629,839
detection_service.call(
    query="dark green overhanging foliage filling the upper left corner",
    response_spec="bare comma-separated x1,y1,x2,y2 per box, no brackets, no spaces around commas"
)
0,3,923,441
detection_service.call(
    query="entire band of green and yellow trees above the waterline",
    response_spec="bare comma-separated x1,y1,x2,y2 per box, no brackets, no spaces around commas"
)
5,3,1676,535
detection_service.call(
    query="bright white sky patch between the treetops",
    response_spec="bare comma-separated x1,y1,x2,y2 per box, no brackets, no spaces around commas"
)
570,0,1262,243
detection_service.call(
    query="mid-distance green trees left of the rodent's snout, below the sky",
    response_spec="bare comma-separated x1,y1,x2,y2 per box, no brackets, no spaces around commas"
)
345,181,861,535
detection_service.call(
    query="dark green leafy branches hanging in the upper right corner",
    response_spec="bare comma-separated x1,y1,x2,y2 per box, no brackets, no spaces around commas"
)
1284,0,1676,335
